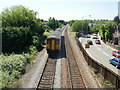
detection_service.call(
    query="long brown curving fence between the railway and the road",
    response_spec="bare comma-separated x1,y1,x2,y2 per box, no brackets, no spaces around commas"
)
76,37,120,88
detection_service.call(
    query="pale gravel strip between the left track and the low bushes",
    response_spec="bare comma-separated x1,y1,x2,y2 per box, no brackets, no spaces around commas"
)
20,49,48,88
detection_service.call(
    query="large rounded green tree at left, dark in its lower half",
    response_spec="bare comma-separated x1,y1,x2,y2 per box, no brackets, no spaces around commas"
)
1,6,44,52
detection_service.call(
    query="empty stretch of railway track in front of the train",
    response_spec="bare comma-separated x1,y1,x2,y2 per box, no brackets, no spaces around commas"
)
37,58,57,89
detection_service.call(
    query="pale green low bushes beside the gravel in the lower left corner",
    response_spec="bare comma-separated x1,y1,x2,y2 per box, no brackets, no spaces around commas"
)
0,49,37,88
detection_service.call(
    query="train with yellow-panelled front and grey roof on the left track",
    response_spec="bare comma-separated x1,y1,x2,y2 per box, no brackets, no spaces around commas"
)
46,28,62,57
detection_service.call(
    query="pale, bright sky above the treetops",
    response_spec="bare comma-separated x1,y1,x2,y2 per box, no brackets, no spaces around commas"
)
0,0,119,21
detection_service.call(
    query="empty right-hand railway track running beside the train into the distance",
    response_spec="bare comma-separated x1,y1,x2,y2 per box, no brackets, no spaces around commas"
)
65,26,86,88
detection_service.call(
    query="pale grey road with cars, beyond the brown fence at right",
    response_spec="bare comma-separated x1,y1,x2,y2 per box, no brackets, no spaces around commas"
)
79,35,120,75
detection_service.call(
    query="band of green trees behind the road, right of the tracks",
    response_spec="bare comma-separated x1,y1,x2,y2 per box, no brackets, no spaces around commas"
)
71,19,118,40
